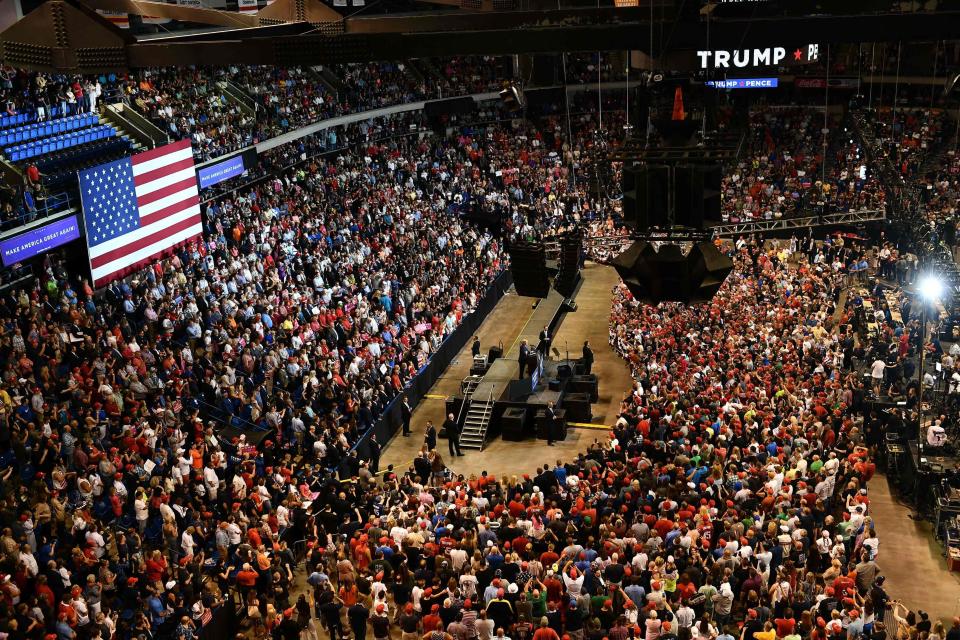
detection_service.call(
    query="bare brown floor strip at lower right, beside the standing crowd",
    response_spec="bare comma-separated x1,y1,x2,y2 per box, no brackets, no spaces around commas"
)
869,474,960,629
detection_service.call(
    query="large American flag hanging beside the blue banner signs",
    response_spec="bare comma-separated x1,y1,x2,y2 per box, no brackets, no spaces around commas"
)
80,140,203,287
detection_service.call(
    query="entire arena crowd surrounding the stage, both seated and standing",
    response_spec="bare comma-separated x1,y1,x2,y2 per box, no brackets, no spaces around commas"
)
0,56,960,640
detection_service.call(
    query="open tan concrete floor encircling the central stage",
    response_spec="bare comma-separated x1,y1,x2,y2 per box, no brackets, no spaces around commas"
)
380,263,632,476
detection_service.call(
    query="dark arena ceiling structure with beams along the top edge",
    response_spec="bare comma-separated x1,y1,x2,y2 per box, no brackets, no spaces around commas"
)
0,0,960,73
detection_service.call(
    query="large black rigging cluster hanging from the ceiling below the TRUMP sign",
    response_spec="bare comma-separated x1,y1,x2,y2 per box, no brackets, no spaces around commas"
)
609,85,744,304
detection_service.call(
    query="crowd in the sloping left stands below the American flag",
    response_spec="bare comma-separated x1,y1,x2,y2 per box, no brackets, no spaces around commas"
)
0,112,580,638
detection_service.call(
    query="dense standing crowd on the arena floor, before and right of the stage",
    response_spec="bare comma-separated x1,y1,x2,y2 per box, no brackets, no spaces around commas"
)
281,235,908,640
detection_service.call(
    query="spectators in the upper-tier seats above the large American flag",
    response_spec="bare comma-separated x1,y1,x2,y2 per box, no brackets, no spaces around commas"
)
0,56,509,168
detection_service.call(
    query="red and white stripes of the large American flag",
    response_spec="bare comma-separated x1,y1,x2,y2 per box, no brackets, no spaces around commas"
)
90,139,203,286
